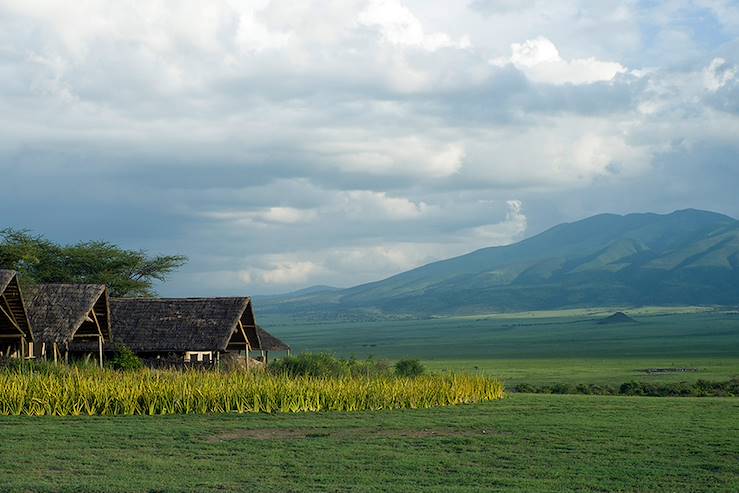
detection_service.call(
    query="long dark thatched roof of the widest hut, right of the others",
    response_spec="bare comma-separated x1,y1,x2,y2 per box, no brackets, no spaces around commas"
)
111,297,258,353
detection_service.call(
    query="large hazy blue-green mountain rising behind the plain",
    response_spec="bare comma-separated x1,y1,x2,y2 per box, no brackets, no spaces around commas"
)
260,209,739,319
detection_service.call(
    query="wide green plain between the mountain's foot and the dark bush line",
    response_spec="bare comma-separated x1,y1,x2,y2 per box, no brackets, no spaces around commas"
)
269,307,739,384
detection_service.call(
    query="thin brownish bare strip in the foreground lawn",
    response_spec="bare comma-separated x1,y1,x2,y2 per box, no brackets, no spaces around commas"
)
205,428,499,443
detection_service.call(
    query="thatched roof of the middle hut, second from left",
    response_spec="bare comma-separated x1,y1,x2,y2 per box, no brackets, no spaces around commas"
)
28,284,111,343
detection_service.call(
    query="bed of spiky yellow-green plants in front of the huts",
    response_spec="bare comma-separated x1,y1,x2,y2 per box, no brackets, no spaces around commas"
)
0,369,503,416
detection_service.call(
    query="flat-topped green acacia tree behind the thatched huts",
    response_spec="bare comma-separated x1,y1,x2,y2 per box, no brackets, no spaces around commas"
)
0,229,187,297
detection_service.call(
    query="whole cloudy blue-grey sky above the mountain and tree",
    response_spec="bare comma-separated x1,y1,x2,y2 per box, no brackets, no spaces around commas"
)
0,0,739,296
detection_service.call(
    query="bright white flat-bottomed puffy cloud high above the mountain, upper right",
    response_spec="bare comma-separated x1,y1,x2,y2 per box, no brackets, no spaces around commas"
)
491,36,626,84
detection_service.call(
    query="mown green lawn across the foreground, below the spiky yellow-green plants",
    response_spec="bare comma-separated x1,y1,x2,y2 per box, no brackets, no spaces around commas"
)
0,394,739,492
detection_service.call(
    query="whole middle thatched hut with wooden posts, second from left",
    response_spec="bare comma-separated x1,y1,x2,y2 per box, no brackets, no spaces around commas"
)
28,284,112,366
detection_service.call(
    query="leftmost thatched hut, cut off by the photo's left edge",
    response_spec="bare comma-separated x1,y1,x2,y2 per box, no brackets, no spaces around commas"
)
0,270,33,358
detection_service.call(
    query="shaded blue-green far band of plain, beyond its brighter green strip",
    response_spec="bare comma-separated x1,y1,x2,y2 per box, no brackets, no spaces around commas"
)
263,310,739,360
